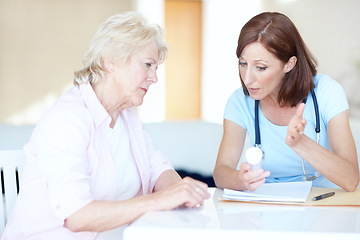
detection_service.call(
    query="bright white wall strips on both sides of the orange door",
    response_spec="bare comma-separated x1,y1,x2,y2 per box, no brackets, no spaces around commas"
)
136,0,261,123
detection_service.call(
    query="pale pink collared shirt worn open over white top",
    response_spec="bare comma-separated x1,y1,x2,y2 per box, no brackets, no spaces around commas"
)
2,84,173,240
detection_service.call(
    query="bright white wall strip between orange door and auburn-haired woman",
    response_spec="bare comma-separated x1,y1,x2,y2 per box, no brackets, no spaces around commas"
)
202,0,261,123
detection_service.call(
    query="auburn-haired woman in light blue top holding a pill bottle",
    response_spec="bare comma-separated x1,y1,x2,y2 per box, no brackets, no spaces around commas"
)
214,12,359,191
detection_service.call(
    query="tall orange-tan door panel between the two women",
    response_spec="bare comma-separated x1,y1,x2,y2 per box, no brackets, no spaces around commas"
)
165,0,202,121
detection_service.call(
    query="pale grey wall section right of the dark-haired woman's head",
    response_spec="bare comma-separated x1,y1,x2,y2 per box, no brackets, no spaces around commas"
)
263,0,360,116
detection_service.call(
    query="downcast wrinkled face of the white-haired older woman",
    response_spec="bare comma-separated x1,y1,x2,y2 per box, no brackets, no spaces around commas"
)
113,42,158,107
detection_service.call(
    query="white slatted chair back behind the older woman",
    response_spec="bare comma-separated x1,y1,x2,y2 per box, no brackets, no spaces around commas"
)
0,150,25,235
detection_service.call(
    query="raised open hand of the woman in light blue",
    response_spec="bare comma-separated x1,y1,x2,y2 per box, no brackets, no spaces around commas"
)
285,103,306,147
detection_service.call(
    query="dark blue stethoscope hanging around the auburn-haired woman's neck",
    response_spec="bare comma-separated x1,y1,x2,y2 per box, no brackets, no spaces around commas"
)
254,90,320,181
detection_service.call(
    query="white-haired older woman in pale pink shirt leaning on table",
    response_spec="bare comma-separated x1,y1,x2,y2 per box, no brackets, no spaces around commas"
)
2,13,209,240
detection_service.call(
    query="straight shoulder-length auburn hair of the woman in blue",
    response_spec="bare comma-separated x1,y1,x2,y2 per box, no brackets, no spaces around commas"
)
236,12,317,107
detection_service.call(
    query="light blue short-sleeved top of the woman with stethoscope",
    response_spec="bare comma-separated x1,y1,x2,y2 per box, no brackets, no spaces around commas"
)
224,75,349,188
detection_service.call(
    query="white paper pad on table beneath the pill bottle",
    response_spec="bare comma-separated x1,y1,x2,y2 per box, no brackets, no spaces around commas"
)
223,181,312,203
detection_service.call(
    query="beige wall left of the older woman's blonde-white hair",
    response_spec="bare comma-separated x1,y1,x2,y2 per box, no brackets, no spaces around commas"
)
0,0,134,124
